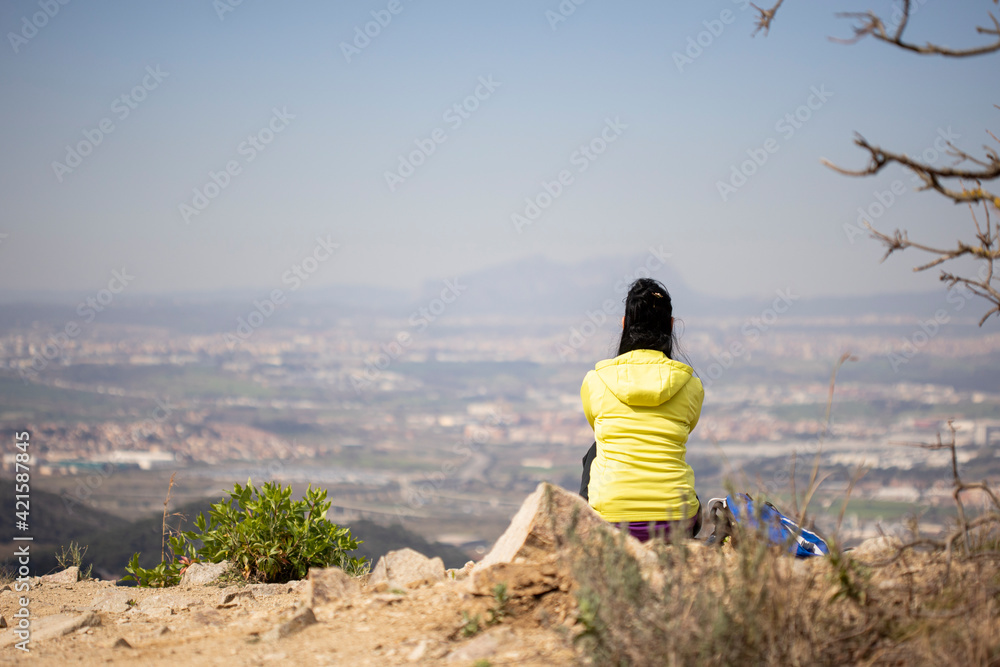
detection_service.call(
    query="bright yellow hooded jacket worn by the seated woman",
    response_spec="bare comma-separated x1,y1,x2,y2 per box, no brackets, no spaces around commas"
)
580,350,705,523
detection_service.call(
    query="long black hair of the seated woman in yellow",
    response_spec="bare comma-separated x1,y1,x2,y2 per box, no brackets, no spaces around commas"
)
618,278,677,359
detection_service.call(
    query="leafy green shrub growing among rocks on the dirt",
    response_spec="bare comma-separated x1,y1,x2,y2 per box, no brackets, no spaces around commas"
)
124,480,368,586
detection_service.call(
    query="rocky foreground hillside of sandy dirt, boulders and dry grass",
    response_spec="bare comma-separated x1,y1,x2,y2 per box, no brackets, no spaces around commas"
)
0,483,1000,666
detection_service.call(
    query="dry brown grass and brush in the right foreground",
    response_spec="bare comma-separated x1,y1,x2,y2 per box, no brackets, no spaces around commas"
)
572,426,1000,665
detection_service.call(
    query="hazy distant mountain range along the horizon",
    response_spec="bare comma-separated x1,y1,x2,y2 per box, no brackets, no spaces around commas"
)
0,250,973,333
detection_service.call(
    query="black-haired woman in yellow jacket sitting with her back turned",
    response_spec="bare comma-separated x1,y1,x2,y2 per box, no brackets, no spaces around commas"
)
580,278,705,542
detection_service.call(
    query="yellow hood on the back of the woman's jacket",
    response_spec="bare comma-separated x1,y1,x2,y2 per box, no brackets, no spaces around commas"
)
594,350,694,407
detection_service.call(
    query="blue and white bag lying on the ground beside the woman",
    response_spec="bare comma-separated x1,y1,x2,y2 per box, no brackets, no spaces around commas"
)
708,493,830,558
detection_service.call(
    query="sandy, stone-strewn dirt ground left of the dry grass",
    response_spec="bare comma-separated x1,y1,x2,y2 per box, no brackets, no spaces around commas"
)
0,580,577,666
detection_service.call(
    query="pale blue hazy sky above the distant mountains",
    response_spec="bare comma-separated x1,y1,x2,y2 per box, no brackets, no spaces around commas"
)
0,0,1000,296
